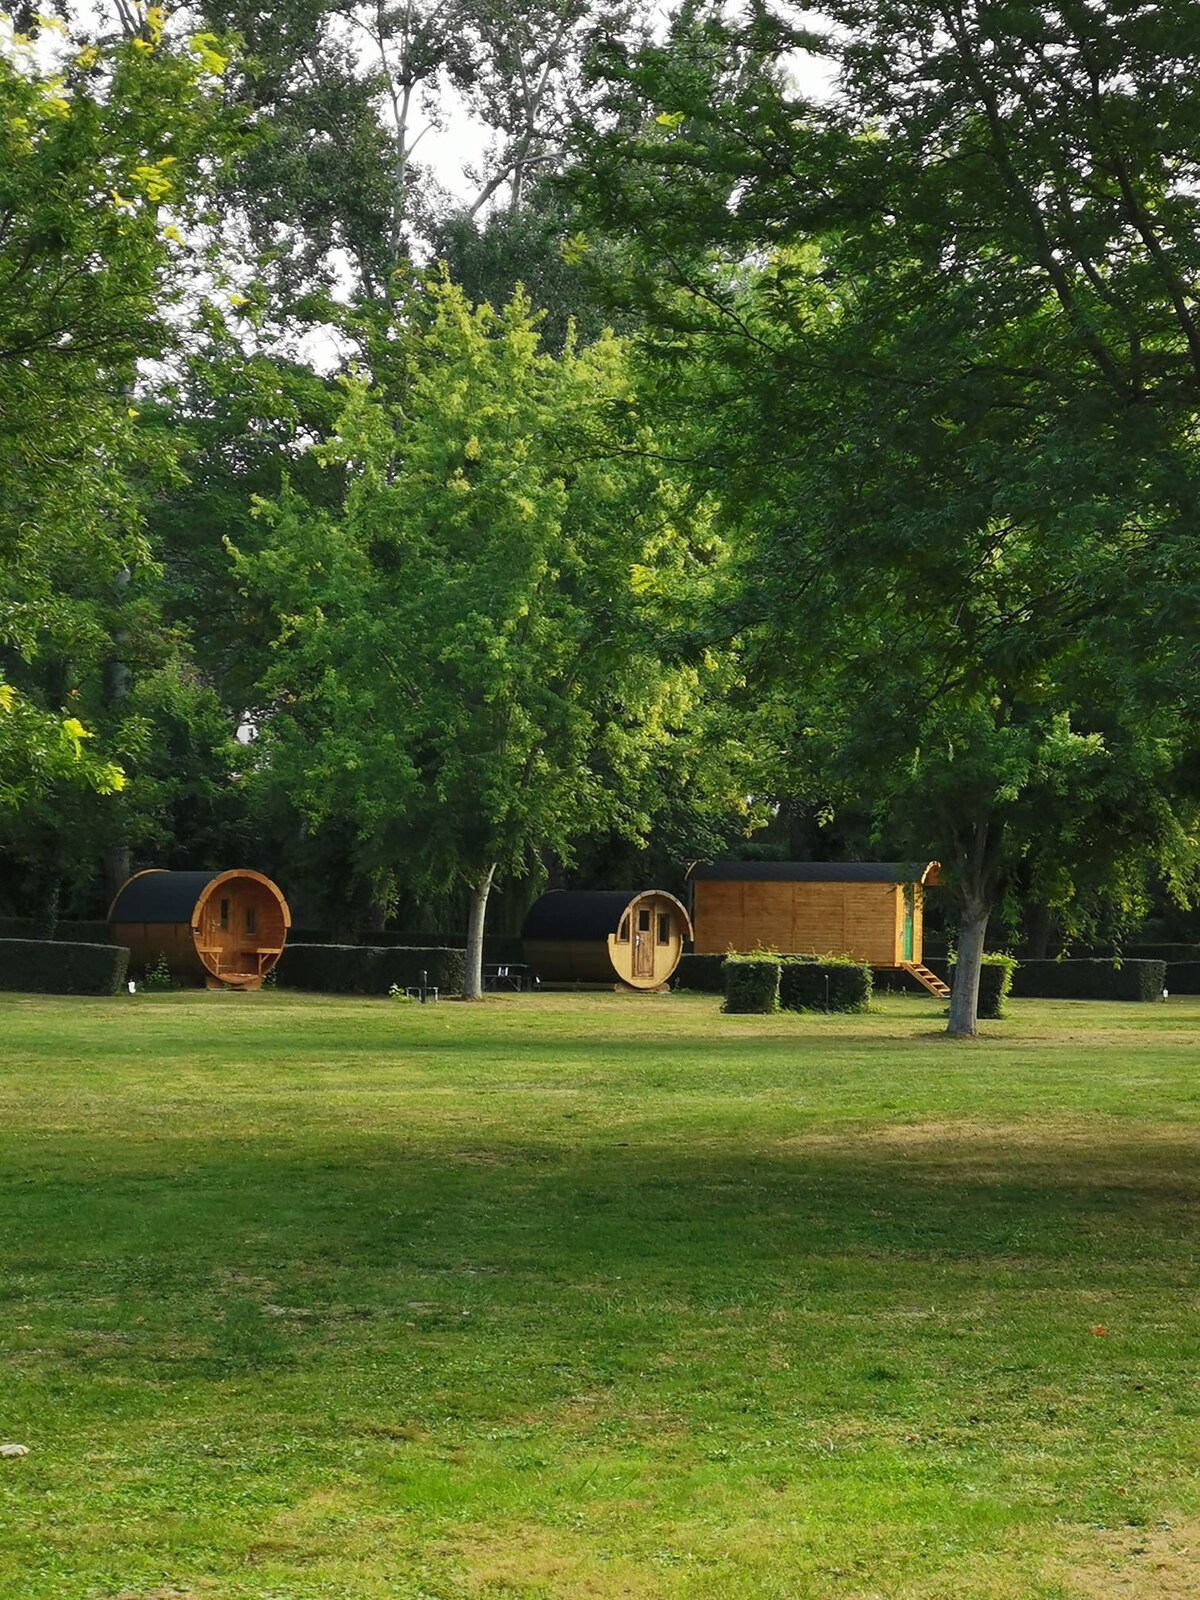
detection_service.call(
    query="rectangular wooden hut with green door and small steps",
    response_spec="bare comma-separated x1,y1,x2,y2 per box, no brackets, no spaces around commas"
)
691,861,949,995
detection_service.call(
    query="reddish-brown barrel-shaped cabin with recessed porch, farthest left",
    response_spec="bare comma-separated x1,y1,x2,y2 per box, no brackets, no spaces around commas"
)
109,869,291,989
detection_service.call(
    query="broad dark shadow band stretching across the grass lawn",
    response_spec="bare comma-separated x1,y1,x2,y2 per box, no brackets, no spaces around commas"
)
0,1136,1200,1365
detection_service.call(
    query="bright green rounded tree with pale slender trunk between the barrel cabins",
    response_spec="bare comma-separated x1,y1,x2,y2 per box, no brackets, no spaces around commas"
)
240,280,742,995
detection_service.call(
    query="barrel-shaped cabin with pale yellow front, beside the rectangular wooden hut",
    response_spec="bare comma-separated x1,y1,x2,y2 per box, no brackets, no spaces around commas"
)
522,890,691,989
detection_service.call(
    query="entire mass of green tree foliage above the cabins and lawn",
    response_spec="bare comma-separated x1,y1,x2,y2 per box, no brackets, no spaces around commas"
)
0,0,1200,1034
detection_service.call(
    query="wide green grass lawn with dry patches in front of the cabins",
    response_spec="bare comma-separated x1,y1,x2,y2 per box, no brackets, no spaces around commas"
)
0,994,1200,1600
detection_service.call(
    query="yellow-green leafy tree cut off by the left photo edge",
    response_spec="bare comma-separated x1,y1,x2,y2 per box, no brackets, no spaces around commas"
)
0,11,241,824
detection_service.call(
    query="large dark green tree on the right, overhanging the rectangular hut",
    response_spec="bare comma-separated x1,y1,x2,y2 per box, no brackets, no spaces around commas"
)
576,0,1200,1034
